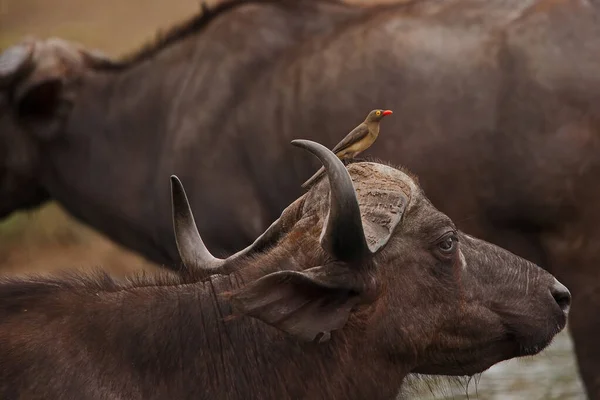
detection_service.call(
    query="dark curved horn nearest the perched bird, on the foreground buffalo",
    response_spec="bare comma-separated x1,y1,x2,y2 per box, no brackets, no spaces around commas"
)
292,140,371,261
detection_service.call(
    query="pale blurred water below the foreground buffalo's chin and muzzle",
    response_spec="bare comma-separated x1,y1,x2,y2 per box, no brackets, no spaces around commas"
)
404,329,586,400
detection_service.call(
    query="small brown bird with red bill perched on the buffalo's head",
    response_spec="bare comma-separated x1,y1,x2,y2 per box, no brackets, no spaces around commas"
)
302,109,392,189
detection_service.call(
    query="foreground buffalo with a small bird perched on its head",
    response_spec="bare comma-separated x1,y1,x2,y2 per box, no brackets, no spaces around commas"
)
0,141,570,400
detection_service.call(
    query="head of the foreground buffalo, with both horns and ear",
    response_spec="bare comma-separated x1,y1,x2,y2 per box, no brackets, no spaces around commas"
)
172,140,570,375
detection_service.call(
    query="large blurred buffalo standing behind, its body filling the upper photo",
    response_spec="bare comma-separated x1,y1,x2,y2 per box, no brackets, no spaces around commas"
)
0,0,600,398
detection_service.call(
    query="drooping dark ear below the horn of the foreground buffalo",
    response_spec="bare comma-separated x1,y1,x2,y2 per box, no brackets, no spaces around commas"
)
231,266,366,342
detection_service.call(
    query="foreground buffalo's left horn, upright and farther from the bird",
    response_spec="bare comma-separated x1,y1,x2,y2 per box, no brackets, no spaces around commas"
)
171,175,224,270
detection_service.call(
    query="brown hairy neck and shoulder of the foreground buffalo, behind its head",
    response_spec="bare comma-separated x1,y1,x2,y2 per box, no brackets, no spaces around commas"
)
0,264,405,399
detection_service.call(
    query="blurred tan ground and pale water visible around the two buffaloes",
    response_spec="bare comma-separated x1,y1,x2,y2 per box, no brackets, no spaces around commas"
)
0,0,585,400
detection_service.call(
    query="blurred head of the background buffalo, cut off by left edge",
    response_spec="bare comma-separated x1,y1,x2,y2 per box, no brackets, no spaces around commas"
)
0,39,108,218
